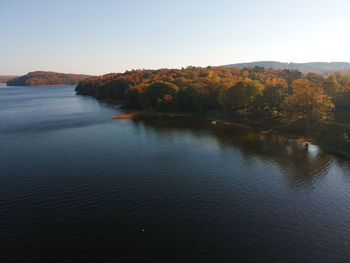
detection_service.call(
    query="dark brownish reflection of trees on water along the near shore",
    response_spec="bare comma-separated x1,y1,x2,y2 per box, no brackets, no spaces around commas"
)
134,116,330,188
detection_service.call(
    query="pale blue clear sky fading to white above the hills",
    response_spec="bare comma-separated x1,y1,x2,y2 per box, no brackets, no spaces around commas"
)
0,0,350,75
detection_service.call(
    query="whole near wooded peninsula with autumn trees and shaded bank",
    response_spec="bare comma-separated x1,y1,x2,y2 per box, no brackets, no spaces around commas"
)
76,66,350,155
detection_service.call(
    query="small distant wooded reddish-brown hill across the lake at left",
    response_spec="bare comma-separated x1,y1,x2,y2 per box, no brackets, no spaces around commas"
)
7,71,91,86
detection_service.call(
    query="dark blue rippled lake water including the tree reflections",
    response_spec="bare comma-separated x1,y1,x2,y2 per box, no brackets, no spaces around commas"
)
0,87,350,262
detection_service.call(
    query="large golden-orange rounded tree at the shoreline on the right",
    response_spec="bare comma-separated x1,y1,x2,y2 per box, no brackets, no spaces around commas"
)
283,79,334,131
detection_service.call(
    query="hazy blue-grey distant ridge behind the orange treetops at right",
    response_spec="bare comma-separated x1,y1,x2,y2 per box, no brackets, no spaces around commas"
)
223,61,350,75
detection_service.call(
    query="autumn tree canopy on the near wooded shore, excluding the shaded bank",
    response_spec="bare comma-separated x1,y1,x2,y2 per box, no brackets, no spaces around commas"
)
76,66,350,129
